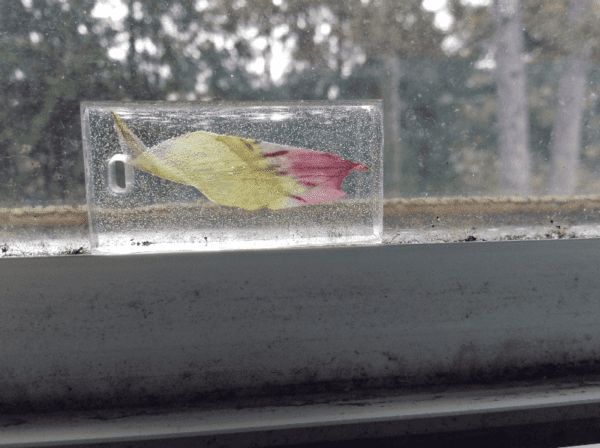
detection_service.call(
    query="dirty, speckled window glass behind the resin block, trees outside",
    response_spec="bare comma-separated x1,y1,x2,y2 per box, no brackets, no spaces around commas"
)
0,0,600,257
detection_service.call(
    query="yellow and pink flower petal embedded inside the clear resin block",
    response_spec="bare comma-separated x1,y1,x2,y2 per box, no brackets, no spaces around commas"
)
112,112,370,210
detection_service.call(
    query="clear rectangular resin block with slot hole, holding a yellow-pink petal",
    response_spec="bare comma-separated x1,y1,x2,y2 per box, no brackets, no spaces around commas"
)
81,101,383,254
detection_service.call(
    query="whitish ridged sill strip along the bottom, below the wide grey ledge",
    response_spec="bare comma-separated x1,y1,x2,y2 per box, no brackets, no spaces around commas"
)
0,381,600,448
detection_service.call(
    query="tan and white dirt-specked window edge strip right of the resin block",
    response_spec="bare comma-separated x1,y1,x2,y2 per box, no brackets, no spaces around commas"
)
383,196,600,244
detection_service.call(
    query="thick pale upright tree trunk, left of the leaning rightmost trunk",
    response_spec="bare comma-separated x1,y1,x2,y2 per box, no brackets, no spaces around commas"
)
493,0,531,196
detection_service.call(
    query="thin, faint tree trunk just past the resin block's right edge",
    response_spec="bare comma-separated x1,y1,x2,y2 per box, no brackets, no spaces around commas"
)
381,54,402,197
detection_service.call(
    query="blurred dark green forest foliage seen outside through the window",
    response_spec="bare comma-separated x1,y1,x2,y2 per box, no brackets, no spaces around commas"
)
0,0,600,204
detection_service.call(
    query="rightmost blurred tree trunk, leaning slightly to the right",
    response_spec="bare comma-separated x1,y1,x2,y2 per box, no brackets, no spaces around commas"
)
548,0,592,195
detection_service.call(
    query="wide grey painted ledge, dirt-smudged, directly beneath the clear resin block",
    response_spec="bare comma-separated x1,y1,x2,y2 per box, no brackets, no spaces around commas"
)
0,239,600,412
